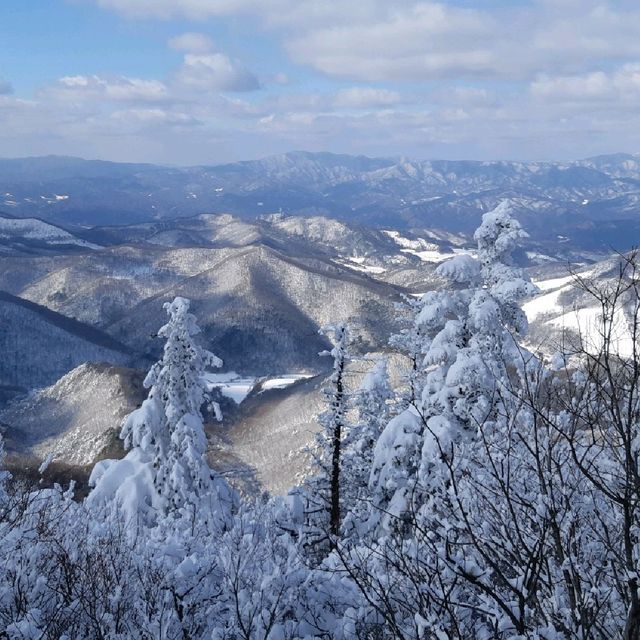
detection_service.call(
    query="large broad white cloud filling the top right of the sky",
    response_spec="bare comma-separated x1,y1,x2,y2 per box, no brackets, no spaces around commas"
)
95,0,640,82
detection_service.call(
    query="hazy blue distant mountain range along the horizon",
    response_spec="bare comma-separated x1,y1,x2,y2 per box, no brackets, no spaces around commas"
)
0,151,640,250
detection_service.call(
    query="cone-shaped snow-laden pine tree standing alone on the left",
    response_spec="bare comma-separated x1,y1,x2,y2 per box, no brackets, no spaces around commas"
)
89,297,233,521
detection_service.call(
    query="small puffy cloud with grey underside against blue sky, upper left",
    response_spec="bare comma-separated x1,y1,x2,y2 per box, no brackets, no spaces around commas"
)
176,53,260,91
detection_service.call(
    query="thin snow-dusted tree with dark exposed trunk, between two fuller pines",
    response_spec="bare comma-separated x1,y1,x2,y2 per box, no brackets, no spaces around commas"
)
303,323,351,547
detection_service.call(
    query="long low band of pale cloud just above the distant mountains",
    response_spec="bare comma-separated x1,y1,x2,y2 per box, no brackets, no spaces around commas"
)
5,74,640,164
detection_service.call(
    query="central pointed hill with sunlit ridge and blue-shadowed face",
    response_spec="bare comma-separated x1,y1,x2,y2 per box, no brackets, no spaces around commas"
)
106,246,400,375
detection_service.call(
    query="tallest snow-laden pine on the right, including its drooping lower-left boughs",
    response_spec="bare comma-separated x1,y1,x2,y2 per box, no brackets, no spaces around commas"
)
371,202,535,525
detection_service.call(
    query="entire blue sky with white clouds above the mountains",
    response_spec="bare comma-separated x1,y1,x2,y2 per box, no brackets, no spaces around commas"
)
0,0,640,165
